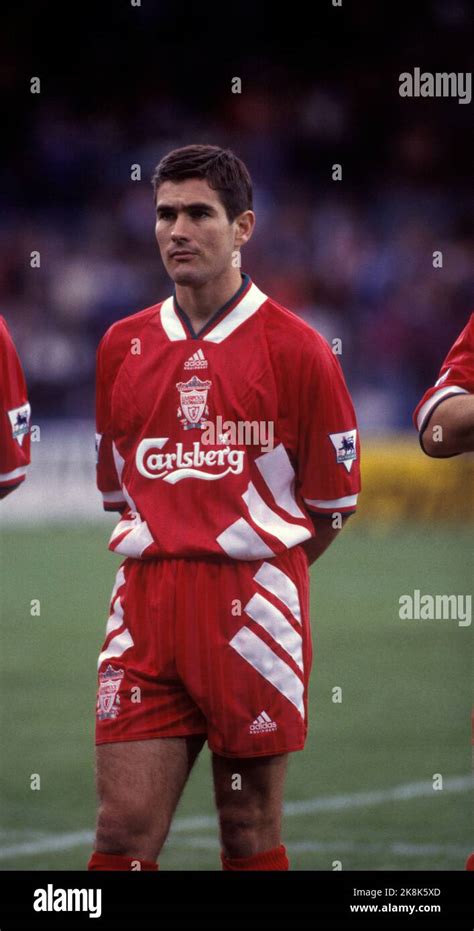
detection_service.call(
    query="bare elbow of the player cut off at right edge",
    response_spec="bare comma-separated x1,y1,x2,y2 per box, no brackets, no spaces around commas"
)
420,394,474,459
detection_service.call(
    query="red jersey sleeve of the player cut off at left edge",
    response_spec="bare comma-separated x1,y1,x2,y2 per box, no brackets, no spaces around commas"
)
0,317,31,498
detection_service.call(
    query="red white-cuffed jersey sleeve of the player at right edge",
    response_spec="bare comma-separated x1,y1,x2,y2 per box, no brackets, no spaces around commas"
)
413,314,474,436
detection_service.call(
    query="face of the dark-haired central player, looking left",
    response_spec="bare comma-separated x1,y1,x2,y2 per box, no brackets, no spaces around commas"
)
155,178,253,287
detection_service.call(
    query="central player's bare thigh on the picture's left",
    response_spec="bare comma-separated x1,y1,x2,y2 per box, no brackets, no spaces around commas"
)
95,734,206,860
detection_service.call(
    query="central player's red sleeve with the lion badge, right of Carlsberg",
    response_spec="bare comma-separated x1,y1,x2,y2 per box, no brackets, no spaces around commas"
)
297,334,360,516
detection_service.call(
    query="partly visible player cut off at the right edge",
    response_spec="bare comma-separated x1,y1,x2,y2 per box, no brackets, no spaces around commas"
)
413,314,474,459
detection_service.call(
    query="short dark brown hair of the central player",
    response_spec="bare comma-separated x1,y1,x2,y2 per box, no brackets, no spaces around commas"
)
151,145,252,223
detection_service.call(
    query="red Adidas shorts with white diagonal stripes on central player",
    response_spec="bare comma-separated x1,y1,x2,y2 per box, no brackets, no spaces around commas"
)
96,546,312,757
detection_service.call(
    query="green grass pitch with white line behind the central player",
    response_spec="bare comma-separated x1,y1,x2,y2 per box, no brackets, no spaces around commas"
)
0,518,472,870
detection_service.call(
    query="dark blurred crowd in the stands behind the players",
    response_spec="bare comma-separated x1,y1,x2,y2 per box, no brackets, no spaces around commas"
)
0,0,474,434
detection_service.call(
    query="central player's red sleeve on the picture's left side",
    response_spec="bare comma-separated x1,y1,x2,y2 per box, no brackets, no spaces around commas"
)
96,330,127,511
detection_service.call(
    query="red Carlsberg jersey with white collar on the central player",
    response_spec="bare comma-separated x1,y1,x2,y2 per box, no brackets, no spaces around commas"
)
97,275,360,560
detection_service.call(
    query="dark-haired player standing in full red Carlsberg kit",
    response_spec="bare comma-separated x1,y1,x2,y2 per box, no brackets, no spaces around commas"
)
88,145,360,871
